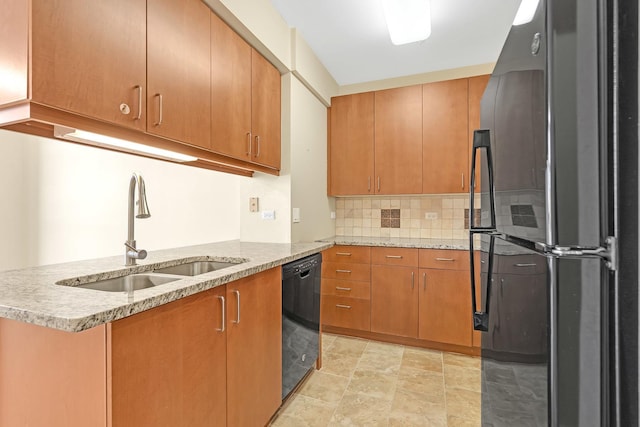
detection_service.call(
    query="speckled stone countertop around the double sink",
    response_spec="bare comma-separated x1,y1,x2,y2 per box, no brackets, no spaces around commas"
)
0,240,333,332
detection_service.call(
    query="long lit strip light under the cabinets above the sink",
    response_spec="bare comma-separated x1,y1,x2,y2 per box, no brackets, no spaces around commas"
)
53,126,198,162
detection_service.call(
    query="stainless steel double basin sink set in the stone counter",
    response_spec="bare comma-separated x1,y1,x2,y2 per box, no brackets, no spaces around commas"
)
56,259,246,292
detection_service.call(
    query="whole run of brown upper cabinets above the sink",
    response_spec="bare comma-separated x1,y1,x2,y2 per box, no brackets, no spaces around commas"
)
0,0,281,176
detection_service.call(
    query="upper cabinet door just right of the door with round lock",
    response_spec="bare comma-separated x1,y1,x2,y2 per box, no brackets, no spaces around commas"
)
146,0,211,148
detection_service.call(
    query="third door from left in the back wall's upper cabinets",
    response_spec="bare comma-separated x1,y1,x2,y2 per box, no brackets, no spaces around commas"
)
422,79,469,193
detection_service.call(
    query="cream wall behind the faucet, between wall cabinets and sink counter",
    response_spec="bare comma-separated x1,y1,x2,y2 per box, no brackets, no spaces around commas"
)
0,130,244,270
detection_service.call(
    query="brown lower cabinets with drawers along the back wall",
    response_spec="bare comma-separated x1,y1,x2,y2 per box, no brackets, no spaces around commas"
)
322,246,479,354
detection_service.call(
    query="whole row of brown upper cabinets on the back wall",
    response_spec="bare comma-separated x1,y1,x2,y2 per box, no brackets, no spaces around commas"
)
329,76,489,196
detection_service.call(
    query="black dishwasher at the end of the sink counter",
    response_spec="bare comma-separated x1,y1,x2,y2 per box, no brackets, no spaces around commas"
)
282,254,322,399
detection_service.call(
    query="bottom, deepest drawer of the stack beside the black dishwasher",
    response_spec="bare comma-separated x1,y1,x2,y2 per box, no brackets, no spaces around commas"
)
322,295,371,331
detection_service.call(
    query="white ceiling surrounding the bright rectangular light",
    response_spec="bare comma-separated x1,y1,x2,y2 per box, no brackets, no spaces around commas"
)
271,0,520,85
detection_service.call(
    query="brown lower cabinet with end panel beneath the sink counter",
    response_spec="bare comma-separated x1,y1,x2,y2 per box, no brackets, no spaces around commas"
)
0,268,282,427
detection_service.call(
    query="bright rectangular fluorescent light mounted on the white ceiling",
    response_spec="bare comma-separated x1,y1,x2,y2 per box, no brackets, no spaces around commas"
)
382,0,431,45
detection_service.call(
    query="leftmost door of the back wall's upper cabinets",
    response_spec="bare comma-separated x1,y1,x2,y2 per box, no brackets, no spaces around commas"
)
329,92,375,196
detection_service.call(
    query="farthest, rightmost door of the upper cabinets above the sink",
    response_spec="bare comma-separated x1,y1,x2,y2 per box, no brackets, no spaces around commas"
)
251,49,281,169
